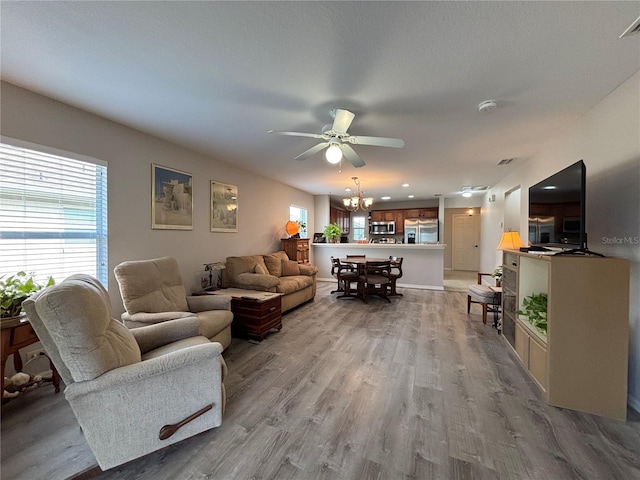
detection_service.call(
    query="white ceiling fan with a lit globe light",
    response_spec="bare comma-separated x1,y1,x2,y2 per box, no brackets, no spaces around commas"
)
268,108,404,168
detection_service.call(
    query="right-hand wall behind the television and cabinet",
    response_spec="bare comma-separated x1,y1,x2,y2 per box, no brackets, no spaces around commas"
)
481,72,640,411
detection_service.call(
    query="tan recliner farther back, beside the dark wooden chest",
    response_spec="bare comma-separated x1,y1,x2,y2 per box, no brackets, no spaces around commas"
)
114,257,233,348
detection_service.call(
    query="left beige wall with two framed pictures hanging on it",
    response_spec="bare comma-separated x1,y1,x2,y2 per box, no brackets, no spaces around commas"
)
0,82,314,316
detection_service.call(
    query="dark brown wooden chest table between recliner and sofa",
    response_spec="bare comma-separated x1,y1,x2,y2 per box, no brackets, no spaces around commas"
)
210,288,282,342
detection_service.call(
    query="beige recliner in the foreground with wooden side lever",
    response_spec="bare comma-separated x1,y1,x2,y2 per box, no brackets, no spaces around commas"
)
23,275,226,470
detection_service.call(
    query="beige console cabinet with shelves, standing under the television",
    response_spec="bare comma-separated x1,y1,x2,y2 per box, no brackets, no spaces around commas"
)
502,251,630,420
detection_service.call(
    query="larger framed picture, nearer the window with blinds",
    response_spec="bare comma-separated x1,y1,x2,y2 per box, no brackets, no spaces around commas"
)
151,163,193,230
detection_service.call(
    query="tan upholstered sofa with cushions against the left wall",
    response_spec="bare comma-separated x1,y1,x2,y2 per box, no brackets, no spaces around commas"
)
222,251,318,313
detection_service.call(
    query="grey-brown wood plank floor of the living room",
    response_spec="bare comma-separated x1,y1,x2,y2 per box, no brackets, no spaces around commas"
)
2,283,640,480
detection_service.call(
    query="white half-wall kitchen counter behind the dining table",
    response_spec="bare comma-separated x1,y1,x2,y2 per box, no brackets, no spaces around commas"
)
311,243,445,290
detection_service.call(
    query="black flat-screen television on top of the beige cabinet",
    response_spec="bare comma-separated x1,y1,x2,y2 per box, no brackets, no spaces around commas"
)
529,160,587,250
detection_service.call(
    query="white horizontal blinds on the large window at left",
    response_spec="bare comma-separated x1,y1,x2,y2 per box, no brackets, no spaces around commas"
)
0,143,108,287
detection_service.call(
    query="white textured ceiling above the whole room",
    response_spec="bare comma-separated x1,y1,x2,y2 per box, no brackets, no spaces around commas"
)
1,1,640,201
